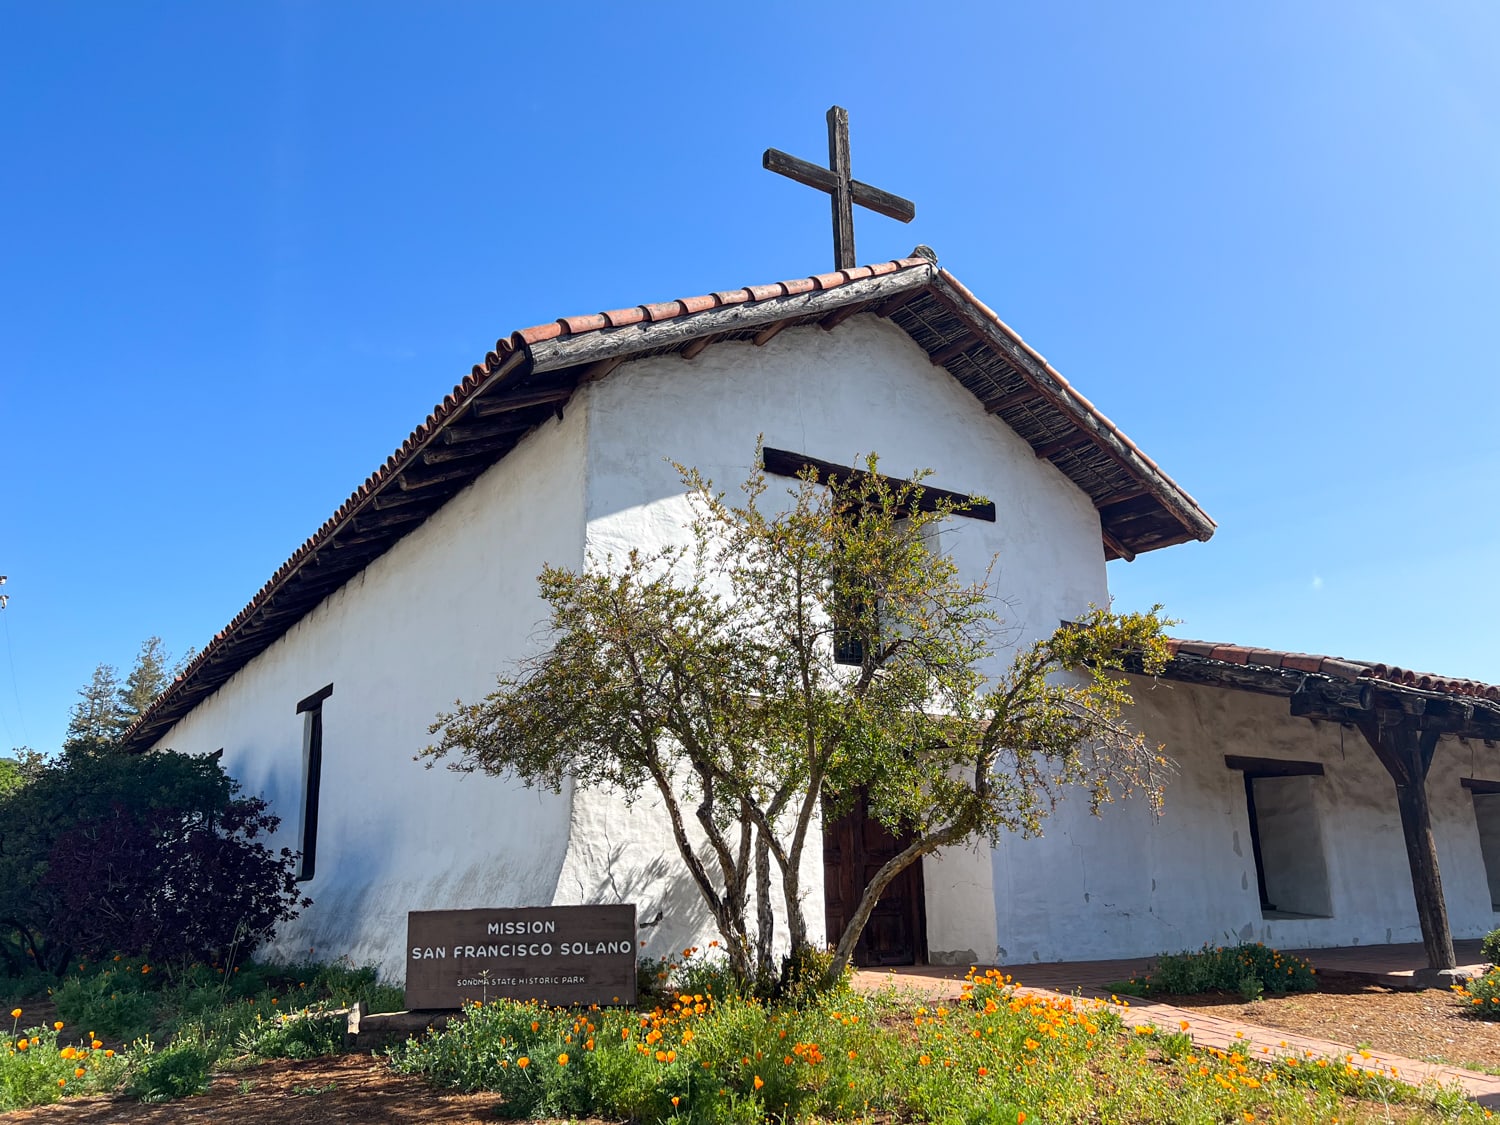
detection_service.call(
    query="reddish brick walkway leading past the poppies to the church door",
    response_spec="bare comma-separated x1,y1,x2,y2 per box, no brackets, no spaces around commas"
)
855,942,1500,1109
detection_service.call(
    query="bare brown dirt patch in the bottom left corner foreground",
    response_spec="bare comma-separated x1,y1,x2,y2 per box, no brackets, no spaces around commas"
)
5,1055,513,1125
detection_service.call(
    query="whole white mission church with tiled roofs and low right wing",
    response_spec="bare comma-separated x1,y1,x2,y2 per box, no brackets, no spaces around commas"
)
128,254,1500,978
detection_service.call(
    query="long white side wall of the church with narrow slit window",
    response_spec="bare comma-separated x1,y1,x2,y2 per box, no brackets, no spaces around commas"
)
146,404,587,981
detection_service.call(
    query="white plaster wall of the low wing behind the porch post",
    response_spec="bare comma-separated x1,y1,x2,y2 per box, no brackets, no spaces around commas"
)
996,678,1500,963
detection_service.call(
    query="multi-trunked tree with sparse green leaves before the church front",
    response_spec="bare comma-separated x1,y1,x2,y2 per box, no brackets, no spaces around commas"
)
425,456,1167,980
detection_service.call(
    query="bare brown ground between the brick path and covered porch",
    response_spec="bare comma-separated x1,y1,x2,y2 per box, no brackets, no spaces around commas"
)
1152,972,1500,1073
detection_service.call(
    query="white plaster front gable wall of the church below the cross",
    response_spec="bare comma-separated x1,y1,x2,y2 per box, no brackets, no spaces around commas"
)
560,317,1107,962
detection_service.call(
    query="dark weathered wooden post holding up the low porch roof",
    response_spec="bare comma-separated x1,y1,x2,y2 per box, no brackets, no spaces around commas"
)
1359,710,1458,969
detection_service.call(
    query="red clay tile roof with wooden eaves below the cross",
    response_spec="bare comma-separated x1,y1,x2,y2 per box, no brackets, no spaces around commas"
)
123,257,1215,750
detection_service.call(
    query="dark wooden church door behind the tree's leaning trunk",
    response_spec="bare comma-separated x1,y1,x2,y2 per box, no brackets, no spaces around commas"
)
824,797,927,966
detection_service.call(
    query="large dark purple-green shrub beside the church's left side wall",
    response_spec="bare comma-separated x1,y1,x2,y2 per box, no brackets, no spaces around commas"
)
0,750,306,975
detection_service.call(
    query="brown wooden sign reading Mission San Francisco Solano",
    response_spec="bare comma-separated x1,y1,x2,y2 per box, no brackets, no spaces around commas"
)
407,905,636,1011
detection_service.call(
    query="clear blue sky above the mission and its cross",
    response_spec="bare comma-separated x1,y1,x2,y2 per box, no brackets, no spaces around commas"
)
0,0,1500,750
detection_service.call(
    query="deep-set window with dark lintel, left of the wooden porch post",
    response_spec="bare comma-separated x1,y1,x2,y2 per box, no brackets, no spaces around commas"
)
1226,756,1334,918
